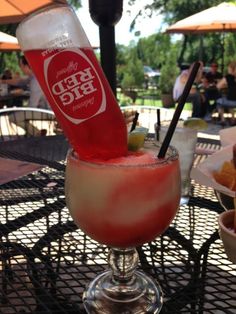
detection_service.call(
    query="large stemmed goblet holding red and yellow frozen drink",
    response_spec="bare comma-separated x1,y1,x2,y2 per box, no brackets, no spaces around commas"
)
65,143,180,314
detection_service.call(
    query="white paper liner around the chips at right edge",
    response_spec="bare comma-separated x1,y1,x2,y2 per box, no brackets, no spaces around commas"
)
190,145,236,197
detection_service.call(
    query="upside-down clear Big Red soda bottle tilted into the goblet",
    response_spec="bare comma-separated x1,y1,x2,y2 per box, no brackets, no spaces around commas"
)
16,5,127,159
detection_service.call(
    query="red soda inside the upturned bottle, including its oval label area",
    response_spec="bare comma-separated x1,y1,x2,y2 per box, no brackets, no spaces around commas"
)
24,48,127,159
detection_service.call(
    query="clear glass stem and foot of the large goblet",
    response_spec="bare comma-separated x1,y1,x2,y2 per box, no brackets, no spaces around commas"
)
83,248,162,314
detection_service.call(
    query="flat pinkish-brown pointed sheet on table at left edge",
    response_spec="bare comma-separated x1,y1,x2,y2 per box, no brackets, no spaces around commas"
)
0,158,44,185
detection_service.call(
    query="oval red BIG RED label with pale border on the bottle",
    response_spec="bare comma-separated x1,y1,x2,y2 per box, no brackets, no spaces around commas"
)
44,48,106,124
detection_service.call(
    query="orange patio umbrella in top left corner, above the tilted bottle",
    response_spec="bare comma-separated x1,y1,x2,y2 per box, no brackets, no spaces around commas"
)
0,0,67,24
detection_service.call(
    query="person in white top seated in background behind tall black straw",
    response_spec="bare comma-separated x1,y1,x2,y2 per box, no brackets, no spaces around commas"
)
173,64,203,118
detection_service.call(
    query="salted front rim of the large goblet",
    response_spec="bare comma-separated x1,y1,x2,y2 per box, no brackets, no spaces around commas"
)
66,142,179,168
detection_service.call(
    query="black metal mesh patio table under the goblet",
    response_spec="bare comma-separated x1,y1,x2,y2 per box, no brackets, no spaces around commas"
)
0,137,236,314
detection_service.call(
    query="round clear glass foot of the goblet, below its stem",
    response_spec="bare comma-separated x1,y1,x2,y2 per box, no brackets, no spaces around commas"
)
83,271,163,314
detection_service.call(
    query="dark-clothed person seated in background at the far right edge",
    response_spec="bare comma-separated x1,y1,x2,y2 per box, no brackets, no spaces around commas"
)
217,61,236,125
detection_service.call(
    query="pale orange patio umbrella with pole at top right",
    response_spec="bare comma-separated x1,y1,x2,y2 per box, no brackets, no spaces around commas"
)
166,2,236,69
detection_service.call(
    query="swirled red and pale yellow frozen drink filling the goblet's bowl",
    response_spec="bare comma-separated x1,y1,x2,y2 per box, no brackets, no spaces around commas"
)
66,145,180,248
